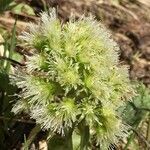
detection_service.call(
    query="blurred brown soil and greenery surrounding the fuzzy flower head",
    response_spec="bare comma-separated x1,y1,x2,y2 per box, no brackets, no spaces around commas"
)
0,0,150,150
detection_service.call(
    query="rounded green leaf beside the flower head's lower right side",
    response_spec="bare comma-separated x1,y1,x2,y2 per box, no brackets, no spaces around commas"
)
123,83,150,127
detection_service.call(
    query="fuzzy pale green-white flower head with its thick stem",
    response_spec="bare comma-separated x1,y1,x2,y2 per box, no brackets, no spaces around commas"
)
12,9,134,150
